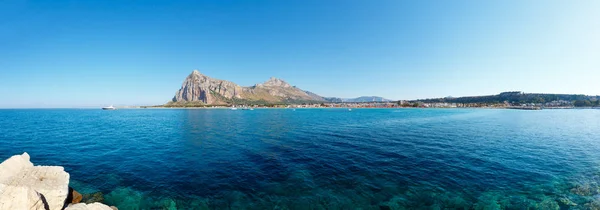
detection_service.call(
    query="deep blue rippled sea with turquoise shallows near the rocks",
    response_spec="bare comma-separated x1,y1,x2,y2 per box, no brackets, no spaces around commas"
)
0,109,600,209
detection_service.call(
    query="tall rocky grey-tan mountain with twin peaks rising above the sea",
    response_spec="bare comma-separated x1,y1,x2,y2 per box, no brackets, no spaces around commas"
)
172,70,324,105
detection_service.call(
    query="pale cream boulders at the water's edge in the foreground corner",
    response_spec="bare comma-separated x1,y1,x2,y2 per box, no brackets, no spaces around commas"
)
0,153,116,210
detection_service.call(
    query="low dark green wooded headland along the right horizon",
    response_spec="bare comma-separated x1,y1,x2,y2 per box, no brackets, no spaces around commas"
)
412,91,598,103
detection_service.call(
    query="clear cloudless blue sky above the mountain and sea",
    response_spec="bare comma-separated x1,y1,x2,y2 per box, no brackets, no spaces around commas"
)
0,0,600,107
